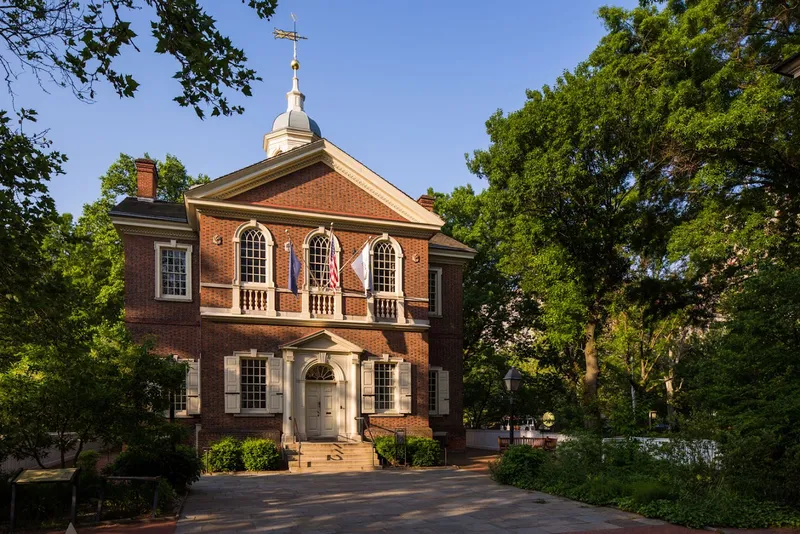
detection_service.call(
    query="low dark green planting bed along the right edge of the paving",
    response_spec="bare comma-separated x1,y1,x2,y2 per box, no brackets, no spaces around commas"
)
490,440,800,528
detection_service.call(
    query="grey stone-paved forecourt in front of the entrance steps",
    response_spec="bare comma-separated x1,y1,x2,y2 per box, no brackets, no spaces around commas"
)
176,469,692,534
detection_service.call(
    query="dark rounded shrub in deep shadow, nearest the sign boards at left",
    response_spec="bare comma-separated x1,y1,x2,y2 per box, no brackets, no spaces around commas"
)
108,445,202,493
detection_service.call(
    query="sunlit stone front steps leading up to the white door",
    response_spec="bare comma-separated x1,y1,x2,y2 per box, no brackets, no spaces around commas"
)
286,441,380,473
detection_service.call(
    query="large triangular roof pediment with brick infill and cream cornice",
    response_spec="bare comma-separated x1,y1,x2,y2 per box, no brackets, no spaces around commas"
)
186,139,443,227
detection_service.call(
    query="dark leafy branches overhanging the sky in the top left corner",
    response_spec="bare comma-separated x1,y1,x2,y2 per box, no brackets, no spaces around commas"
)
0,0,277,118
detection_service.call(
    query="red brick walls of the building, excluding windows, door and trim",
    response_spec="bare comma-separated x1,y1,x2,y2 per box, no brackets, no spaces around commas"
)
115,158,472,449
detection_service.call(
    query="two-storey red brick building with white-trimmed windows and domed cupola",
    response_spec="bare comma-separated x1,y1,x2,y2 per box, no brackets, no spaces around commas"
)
111,62,474,460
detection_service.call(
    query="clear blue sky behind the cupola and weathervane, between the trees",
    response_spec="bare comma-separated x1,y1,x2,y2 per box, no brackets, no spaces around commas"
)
0,0,637,218
